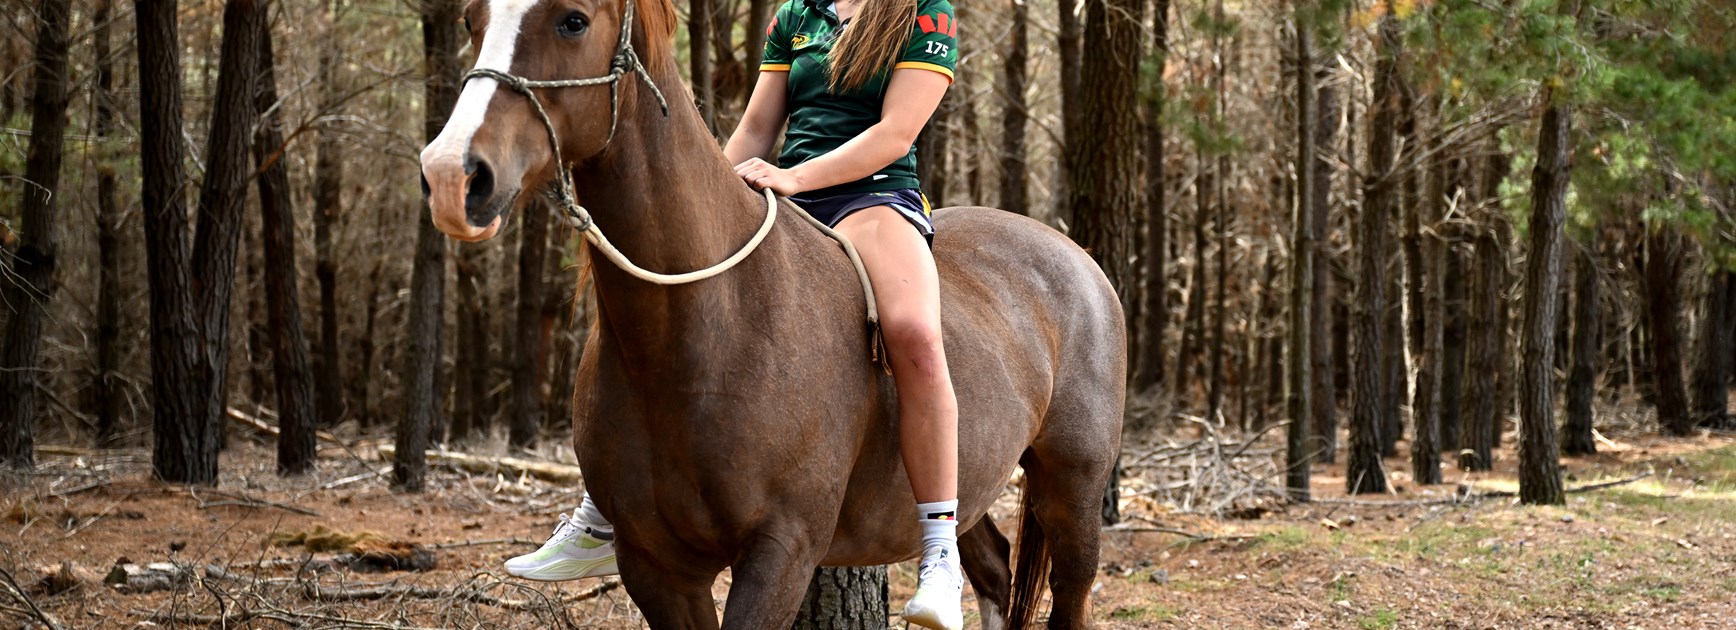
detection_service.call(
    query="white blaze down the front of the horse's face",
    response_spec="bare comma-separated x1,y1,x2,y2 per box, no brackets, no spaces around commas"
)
422,0,542,168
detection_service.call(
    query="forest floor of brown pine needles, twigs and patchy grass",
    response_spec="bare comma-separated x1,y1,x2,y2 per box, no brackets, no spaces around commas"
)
0,411,1736,628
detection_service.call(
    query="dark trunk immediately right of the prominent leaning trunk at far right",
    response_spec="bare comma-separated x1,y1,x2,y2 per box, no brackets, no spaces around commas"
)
1561,236,1602,455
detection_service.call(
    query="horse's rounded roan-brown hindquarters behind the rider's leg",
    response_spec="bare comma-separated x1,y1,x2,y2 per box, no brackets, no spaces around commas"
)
934,207,1127,489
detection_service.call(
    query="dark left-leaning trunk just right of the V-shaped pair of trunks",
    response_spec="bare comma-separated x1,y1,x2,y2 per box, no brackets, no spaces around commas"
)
253,12,319,476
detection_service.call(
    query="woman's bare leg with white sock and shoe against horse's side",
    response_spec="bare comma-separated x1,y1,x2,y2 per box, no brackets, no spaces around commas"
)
838,207,963,630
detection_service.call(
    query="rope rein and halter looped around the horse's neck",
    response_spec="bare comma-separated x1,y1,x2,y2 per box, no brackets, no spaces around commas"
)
464,0,891,347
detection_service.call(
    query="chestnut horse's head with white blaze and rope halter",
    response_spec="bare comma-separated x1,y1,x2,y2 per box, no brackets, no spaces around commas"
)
422,0,674,241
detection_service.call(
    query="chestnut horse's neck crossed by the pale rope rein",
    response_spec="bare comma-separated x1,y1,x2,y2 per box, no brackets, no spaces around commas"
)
575,66,790,371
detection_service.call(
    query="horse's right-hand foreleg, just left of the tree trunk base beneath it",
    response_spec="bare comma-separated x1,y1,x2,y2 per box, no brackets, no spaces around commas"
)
724,536,819,630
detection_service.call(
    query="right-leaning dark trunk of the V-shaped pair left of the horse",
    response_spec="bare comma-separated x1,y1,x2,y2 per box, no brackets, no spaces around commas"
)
193,0,264,468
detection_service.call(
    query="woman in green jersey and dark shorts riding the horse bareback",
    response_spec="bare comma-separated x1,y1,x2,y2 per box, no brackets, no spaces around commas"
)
507,0,965,628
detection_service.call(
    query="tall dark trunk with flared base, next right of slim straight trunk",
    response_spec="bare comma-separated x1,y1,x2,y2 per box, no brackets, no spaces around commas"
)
1345,0,1399,495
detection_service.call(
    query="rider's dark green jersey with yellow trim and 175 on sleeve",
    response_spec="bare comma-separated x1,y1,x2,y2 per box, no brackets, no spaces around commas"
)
760,0,958,198
